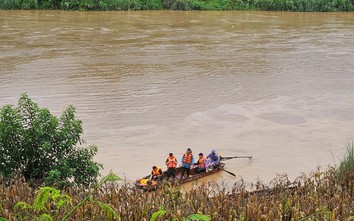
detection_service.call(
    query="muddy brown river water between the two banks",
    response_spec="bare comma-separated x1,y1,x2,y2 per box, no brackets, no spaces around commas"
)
0,11,354,186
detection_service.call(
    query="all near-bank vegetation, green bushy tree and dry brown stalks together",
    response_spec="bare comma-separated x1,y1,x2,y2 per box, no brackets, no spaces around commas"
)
0,94,354,221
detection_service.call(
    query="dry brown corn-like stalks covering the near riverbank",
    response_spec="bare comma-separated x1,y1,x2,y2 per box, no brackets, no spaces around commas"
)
0,163,354,221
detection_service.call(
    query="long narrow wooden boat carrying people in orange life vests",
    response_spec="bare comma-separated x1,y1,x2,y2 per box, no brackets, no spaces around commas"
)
135,162,225,190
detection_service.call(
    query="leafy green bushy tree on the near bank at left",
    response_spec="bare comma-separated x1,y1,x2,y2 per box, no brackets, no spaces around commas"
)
0,94,103,187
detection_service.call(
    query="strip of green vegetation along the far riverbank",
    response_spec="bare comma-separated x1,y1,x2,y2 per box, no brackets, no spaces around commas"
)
0,0,354,12
